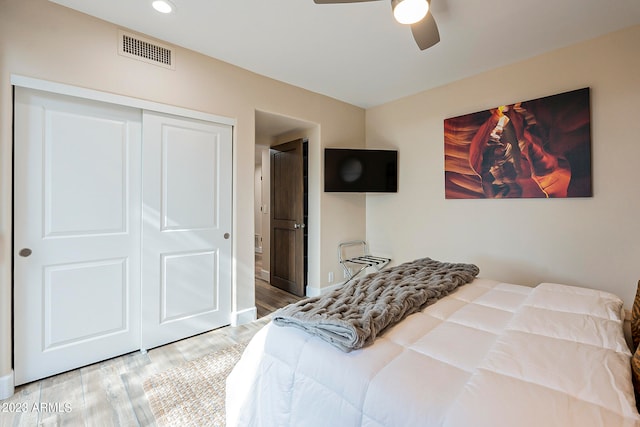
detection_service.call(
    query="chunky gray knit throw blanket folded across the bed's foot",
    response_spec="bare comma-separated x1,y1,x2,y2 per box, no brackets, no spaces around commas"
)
273,258,480,352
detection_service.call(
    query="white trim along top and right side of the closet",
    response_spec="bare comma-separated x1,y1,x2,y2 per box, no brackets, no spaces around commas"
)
8,74,239,388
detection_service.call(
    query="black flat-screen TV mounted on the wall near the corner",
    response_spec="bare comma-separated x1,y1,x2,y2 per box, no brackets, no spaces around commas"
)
324,148,398,193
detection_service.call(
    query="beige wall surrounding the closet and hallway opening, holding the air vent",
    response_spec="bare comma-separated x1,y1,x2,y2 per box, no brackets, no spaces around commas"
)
0,0,365,388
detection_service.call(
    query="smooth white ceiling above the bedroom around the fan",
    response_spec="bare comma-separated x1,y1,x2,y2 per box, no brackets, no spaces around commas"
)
51,0,640,108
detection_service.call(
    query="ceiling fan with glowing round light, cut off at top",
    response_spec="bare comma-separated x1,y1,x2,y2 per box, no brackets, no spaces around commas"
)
313,0,440,50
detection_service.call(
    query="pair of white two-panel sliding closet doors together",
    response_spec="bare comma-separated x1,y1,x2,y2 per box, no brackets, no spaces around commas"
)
13,87,232,385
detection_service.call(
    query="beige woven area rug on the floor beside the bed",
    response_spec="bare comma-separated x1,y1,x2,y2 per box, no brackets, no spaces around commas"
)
143,342,247,427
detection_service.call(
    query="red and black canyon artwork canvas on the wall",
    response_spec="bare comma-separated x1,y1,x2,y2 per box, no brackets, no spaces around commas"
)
444,88,592,199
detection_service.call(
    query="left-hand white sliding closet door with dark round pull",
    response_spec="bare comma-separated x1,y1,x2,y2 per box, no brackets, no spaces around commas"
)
13,87,141,384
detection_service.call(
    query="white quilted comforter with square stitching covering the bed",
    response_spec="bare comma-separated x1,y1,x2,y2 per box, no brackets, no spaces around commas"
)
226,279,640,427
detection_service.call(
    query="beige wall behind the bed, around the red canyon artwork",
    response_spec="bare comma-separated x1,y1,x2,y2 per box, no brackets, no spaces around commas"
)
366,26,640,307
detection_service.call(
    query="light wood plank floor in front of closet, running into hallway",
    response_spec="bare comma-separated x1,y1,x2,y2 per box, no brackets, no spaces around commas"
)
0,257,300,427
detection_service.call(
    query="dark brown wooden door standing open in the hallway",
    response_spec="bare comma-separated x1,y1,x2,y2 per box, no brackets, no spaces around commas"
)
270,140,306,296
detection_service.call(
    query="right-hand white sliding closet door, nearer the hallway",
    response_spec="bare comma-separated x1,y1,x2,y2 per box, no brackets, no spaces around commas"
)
142,111,232,349
